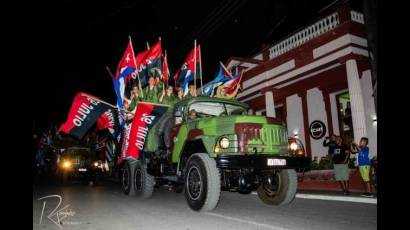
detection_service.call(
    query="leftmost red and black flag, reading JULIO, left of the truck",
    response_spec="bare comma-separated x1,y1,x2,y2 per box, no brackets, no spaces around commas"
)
59,92,111,139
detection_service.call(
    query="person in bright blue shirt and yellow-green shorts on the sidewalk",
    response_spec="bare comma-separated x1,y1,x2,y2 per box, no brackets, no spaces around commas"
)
350,137,372,197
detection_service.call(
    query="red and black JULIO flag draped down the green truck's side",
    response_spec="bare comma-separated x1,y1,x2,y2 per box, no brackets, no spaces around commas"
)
123,102,168,159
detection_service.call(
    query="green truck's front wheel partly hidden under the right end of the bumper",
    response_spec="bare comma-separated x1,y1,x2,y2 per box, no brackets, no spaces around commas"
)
257,169,297,205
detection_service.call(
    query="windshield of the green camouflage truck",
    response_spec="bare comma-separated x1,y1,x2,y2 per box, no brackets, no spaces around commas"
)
189,102,246,117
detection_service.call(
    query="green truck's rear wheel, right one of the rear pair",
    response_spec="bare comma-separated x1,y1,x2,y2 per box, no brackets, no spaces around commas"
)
133,161,155,199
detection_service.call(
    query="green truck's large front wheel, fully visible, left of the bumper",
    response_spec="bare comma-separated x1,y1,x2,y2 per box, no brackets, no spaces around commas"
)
184,153,221,211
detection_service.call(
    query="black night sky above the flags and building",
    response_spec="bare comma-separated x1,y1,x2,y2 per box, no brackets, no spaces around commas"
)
30,0,362,133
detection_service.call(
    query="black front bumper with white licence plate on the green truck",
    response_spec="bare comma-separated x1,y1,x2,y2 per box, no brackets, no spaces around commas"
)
215,154,311,172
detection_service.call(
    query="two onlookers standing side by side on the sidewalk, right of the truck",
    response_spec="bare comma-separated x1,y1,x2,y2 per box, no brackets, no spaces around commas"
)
323,135,373,197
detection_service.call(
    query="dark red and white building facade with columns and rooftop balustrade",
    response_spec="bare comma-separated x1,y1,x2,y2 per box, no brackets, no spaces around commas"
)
225,4,377,158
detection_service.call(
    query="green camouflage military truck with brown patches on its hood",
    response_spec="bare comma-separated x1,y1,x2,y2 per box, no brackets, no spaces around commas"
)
121,96,310,211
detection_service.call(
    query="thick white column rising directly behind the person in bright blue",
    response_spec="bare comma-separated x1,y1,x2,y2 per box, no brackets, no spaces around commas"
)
346,59,367,144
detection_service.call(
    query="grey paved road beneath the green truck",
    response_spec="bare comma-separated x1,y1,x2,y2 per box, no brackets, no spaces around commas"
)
33,182,377,230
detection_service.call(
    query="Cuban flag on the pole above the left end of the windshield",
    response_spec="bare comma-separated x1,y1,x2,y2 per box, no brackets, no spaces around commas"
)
174,45,201,95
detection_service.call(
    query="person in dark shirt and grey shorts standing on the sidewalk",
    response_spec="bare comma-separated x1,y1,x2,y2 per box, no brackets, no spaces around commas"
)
330,136,350,195
